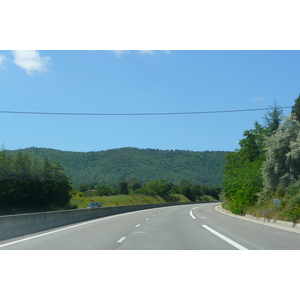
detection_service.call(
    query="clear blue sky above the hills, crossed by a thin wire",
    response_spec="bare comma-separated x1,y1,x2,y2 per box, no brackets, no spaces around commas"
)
0,50,300,152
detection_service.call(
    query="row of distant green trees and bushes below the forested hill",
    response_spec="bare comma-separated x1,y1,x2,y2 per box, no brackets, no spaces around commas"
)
73,177,221,201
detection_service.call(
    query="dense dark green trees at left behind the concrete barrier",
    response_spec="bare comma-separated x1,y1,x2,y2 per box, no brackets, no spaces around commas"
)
0,149,72,212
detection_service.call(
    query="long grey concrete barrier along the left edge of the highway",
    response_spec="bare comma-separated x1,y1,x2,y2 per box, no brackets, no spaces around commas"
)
0,202,217,241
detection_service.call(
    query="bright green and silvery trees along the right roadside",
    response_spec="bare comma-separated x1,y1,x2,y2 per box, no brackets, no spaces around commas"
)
223,96,300,221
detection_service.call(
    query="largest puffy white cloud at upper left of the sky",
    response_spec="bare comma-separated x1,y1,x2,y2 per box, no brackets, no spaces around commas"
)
12,50,51,75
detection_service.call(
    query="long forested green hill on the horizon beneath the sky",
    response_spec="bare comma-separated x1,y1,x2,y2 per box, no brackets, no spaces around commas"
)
9,148,227,187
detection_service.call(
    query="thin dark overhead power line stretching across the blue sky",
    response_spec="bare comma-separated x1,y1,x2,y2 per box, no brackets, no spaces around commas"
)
0,106,292,116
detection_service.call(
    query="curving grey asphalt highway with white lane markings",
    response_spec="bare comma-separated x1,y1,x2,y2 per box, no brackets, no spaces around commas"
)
0,203,300,250
